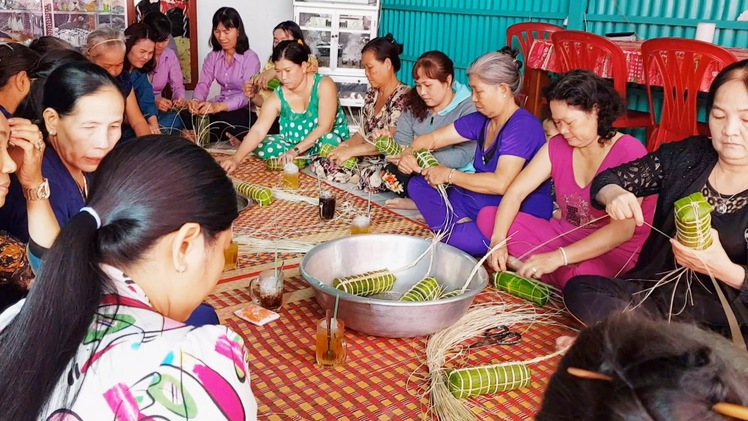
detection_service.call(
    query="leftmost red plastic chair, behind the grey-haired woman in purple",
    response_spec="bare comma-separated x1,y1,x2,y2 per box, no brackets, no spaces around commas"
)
506,22,564,118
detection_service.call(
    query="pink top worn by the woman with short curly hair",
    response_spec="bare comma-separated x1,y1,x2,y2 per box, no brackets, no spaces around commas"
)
548,135,657,256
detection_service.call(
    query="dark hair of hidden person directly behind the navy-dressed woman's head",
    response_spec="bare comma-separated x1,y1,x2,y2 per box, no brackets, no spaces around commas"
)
15,49,87,126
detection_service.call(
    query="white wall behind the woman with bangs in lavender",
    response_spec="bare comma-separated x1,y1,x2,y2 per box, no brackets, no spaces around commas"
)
196,0,293,95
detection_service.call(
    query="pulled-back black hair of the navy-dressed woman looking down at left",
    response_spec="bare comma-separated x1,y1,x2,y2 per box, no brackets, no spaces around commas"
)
41,61,125,136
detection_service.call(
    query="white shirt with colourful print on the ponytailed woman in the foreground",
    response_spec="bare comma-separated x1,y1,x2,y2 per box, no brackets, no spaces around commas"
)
0,265,257,421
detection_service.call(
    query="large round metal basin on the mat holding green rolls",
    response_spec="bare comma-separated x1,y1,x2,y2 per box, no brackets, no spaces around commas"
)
300,234,488,338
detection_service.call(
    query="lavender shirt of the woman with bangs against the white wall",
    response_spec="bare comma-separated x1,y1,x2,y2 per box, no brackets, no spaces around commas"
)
192,50,260,111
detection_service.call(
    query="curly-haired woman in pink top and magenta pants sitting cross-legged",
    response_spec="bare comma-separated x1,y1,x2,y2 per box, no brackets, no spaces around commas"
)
478,70,657,287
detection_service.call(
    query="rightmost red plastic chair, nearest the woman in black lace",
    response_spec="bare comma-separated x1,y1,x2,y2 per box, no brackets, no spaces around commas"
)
642,38,738,151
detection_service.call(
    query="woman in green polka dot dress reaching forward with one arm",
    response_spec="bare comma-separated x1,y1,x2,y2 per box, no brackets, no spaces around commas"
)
221,41,350,174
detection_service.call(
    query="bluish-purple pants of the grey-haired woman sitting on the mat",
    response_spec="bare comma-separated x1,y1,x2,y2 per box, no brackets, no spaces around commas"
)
408,175,501,256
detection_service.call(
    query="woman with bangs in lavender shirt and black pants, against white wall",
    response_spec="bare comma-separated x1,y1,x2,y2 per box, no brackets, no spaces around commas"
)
185,7,260,141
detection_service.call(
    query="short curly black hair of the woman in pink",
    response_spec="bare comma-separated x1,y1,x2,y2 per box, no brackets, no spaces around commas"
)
545,70,626,144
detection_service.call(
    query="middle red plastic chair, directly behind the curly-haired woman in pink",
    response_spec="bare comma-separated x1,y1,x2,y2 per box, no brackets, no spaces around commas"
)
551,31,652,132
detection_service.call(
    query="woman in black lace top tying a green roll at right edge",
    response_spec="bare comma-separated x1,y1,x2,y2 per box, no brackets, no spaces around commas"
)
564,60,748,338
